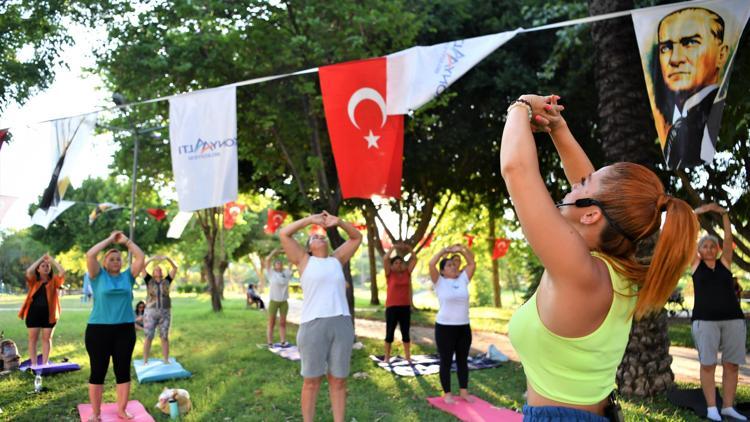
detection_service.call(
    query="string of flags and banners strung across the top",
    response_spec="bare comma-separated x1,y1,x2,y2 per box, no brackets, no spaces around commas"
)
0,0,750,232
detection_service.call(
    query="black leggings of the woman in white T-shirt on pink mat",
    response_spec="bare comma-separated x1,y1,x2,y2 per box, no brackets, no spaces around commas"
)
435,323,471,393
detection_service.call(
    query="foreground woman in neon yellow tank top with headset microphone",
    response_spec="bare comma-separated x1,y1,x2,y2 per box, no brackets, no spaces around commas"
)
500,95,698,421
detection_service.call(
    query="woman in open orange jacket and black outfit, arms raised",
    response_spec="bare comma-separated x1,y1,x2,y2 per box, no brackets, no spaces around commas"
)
18,254,65,367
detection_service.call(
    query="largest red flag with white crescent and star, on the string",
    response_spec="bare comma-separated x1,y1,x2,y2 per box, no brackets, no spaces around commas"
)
318,57,404,199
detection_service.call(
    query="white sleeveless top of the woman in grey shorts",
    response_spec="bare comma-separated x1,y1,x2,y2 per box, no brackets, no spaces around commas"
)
300,256,351,324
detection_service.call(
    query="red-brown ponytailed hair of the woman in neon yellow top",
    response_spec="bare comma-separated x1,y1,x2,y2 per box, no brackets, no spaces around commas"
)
597,163,699,318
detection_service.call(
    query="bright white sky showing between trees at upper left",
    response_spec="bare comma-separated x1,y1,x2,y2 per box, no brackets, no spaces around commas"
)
0,27,115,229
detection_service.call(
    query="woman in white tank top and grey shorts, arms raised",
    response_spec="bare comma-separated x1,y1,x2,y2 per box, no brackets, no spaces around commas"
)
279,211,362,422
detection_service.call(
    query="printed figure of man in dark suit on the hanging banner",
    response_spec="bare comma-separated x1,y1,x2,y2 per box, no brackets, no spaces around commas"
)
652,7,729,169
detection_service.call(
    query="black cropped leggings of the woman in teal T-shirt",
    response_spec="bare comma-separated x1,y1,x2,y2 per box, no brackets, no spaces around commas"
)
85,322,135,385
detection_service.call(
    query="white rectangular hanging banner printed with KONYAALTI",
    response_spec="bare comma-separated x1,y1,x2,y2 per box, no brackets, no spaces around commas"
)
169,86,237,212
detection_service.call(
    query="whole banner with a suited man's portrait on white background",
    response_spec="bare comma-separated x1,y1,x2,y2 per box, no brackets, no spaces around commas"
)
632,0,750,169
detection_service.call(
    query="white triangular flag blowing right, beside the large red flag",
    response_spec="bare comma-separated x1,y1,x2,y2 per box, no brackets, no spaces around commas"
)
386,30,519,115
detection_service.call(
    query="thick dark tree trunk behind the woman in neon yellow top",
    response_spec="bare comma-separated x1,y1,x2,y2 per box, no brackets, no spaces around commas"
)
589,0,674,397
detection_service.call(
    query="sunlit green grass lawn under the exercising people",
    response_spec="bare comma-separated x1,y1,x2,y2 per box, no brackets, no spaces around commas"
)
0,292,750,421
